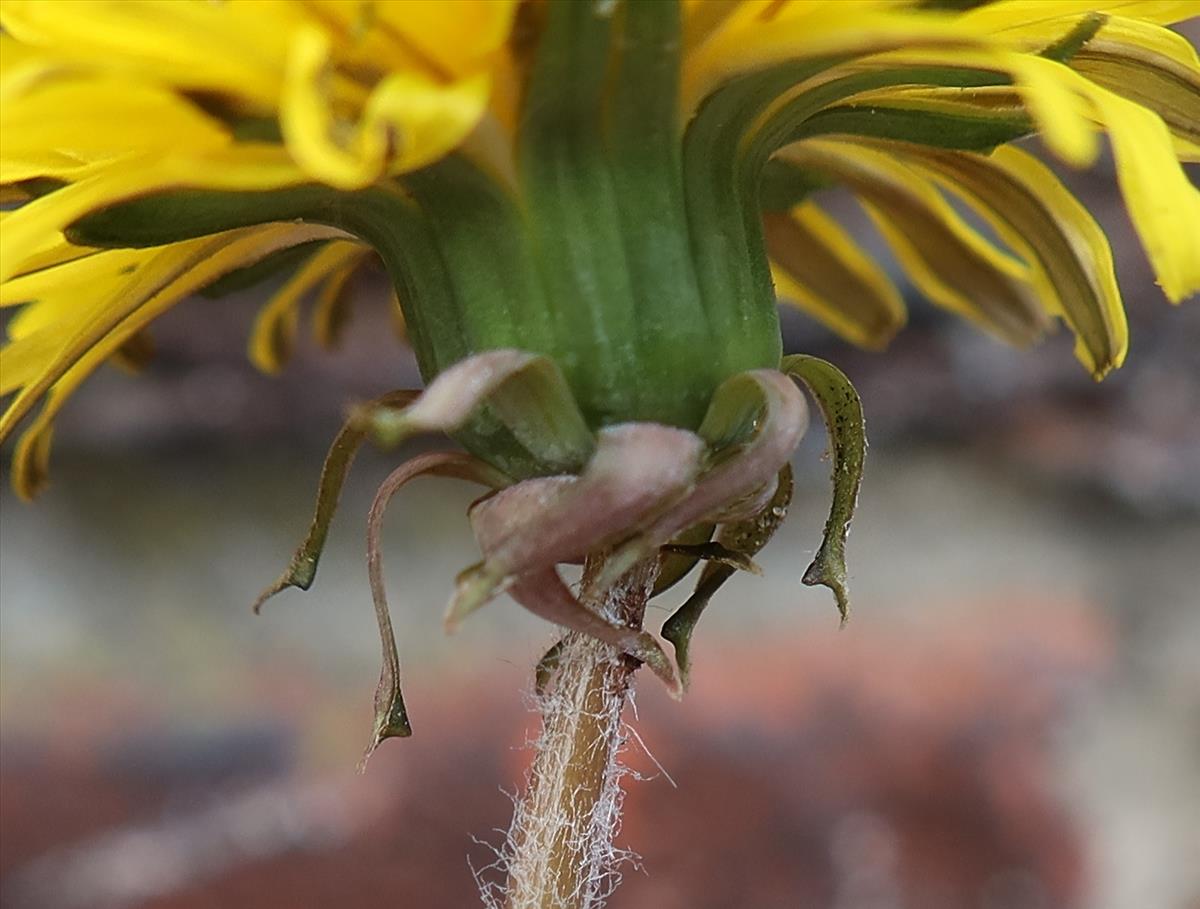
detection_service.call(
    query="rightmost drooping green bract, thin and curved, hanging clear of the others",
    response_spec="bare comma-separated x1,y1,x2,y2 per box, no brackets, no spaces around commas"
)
780,354,866,622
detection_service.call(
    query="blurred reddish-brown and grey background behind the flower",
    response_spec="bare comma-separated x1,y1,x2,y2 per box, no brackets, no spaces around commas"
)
0,152,1200,909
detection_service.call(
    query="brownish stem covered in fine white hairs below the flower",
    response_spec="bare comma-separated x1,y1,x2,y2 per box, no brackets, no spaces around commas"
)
505,556,658,909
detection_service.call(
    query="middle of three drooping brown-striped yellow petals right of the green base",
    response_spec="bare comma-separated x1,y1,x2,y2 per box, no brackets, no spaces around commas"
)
784,139,1046,345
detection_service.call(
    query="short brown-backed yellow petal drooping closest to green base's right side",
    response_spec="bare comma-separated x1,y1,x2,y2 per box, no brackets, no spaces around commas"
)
763,201,906,350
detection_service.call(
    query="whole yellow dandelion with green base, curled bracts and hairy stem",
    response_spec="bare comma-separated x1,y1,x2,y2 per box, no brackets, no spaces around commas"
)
0,0,1200,907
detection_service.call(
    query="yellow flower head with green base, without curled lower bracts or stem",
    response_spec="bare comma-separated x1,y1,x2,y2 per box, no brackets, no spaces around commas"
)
0,0,1200,506
